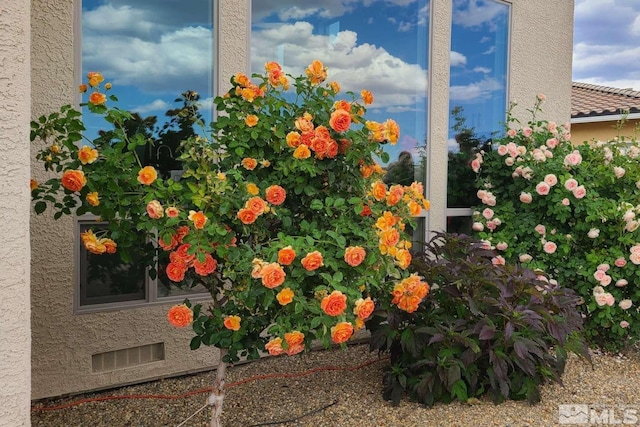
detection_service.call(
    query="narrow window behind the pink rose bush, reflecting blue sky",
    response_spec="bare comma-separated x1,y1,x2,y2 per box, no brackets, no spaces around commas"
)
447,0,510,233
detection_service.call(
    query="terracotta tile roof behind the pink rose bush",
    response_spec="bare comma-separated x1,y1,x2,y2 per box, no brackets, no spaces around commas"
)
571,82,640,118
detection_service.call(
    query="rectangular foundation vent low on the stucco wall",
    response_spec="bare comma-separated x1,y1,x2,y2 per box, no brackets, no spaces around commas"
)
91,342,164,372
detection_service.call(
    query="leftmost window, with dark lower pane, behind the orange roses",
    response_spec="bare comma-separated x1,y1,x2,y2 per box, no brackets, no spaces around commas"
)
76,0,215,309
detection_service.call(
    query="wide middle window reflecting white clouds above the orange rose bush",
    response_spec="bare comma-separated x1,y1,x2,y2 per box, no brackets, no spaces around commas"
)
251,0,430,240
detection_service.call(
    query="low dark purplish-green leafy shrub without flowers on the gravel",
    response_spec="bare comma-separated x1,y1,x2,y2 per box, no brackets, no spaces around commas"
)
368,233,589,405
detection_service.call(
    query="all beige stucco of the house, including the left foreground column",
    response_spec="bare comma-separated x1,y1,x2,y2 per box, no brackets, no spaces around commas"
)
11,0,573,404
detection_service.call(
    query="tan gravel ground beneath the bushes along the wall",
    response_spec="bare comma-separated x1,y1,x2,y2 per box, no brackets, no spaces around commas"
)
31,344,640,427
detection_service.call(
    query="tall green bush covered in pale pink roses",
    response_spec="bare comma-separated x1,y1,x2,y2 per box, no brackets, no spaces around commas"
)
473,98,640,349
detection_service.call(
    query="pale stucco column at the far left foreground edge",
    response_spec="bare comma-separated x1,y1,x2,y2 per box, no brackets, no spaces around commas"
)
0,0,31,427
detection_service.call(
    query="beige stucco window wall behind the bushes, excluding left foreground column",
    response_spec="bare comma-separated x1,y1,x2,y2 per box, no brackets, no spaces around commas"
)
31,0,573,398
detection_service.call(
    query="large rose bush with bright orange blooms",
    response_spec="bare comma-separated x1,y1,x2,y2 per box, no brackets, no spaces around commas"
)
31,61,429,368
